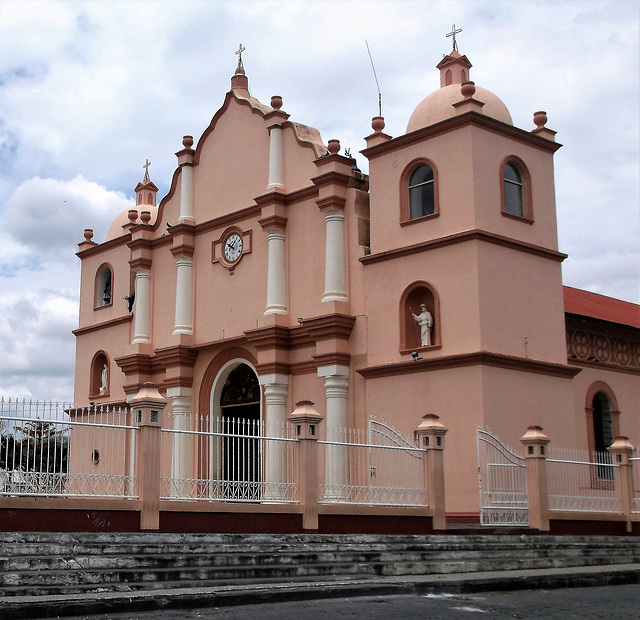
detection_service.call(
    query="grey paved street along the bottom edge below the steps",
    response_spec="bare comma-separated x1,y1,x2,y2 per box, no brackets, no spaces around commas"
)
66,585,640,620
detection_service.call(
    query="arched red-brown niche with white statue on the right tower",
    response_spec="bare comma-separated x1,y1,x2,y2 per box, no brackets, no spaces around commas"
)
400,282,440,353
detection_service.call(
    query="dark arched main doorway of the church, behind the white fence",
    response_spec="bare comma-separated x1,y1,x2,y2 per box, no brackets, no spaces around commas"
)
212,362,262,500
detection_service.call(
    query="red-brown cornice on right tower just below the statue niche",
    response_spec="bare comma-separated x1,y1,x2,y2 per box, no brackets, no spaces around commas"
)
356,351,580,379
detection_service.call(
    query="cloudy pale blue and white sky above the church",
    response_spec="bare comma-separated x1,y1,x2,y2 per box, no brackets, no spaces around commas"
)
0,0,640,400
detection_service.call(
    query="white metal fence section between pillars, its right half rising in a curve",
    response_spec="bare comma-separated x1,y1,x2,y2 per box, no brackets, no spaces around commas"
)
319,420,428,506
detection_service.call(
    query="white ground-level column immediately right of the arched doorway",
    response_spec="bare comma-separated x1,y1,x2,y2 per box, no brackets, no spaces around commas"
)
264,383,288,501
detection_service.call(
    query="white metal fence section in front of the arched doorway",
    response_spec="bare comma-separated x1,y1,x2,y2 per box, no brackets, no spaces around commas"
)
160,414,298,503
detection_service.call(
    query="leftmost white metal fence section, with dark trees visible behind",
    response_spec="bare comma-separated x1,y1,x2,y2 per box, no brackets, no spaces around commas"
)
0,399,138,497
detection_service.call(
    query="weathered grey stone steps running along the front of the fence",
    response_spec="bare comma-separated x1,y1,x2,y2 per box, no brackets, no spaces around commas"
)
0,533,640,603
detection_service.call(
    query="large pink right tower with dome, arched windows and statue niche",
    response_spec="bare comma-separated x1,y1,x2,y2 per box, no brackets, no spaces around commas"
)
361,38,573,464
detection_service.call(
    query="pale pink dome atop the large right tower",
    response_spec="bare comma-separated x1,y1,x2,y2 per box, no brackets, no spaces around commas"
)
407,84,513,133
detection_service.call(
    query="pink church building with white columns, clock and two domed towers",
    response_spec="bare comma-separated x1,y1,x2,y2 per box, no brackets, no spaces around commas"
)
74,46,640,520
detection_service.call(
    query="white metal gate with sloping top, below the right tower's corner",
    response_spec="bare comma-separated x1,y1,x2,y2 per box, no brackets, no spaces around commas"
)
476,428,529,527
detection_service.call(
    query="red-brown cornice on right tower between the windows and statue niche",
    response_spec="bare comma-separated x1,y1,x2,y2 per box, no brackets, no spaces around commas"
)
358,228,567,265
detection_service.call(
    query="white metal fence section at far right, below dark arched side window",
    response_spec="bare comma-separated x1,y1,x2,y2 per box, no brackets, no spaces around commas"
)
547,446,622,513
